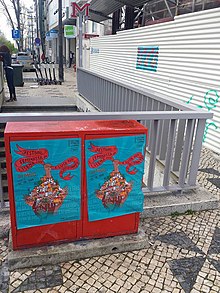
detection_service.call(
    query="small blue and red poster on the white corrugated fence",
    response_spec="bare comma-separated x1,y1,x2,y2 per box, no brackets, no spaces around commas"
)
136,46,159,72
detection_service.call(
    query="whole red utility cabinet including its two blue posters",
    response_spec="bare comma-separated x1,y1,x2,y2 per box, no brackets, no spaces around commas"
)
5,120,147,249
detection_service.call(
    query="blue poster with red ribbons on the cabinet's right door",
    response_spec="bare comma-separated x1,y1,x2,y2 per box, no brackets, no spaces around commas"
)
85,135,146,221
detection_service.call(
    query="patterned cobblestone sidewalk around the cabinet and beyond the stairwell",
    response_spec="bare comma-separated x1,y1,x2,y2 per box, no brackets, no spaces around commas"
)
0,69,220,293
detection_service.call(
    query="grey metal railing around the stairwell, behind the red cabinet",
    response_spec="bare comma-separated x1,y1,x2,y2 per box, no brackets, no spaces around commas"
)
0,69,212,207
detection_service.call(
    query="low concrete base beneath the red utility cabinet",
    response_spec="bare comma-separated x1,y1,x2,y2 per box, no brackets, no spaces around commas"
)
8,229,149,271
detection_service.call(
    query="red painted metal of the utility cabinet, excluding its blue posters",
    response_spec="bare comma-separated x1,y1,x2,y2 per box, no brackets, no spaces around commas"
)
5,120,147,249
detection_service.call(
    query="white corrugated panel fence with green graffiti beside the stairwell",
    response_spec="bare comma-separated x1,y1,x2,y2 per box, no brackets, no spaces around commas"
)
90,8,220,152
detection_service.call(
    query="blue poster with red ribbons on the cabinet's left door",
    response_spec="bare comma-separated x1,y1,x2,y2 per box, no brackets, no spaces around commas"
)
10,138,81,229
